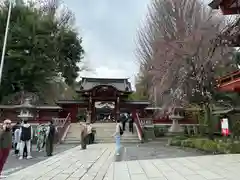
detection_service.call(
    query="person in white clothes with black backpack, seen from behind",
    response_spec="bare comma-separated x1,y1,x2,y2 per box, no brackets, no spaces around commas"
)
19,121,33,160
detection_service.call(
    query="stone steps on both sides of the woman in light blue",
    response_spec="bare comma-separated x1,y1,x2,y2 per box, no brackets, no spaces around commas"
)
93,123,140,143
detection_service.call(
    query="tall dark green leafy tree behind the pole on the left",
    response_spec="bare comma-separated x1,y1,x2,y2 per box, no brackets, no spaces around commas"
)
0,0,84,100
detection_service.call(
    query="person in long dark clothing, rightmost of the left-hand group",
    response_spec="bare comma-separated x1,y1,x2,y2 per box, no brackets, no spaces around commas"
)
46,121,57,156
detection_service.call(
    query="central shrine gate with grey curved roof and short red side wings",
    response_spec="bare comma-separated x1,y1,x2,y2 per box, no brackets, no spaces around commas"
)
56,77,149,123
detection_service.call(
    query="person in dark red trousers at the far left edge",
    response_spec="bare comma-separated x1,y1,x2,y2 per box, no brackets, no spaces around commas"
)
0,119,12,178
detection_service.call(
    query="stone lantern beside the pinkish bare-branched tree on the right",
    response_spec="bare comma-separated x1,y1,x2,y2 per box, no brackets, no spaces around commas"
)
168,107,184,134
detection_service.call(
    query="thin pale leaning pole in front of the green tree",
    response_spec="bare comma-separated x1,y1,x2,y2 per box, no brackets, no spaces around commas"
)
0,0,12,85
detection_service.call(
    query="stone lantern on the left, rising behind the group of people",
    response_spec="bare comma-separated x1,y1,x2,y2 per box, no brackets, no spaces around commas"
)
15,98,35,121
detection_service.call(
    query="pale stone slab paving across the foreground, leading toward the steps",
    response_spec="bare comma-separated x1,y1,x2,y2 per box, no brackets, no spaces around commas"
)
6,144,240,180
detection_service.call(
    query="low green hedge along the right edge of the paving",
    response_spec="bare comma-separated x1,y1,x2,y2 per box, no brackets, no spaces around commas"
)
169,137,240,154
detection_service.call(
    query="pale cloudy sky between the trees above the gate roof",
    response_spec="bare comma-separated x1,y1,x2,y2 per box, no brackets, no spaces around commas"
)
64,0,150,83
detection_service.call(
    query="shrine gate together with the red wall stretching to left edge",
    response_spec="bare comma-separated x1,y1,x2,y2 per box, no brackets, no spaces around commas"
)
0,77,150,123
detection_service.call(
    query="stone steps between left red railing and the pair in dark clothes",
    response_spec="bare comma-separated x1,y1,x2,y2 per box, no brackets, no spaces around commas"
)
64,123,81,144
